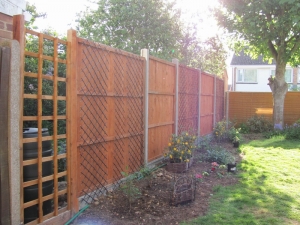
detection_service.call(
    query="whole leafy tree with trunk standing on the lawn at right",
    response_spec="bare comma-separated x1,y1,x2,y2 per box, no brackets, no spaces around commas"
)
216,0,300,126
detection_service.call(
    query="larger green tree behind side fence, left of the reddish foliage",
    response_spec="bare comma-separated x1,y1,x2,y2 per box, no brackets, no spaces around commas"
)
77,0,181,60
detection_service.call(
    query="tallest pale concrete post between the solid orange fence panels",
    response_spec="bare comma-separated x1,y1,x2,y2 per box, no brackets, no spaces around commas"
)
141,49,149,166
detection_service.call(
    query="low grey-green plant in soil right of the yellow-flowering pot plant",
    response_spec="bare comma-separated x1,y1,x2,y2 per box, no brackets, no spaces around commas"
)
204,146,235,165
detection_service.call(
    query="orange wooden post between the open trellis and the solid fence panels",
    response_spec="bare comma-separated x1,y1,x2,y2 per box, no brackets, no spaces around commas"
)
67,30,79,215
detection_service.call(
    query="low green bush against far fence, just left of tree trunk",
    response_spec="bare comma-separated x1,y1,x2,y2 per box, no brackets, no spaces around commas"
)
247,115,273,133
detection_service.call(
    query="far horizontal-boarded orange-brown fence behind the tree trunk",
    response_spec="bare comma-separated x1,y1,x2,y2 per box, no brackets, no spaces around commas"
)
226,92,300,125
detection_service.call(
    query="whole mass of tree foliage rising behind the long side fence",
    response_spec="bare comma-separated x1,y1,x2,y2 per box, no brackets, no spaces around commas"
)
77,0,226,75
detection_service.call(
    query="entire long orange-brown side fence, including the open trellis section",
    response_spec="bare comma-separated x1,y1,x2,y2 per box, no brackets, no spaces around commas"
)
14,14,224,224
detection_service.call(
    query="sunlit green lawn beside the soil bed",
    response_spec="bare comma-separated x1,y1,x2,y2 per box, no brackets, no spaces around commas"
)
183,137,300,225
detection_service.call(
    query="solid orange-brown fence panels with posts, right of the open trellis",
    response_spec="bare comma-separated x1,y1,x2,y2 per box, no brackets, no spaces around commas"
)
68,31,224,210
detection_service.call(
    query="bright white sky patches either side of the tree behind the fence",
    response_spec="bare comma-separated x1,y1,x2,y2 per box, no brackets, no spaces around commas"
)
27,0,217,39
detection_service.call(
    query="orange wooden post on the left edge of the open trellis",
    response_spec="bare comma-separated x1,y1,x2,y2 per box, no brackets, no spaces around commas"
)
13,15,25,223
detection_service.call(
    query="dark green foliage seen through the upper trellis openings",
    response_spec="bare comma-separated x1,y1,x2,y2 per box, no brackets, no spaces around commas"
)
23,30,66,135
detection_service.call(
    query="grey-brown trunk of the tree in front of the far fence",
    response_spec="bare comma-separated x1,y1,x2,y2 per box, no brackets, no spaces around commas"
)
268,63,288,129
